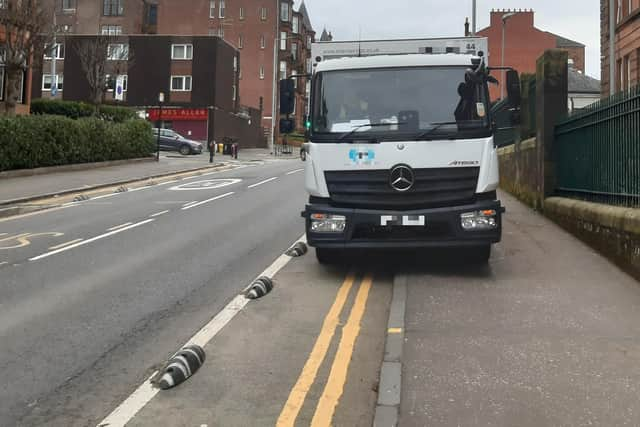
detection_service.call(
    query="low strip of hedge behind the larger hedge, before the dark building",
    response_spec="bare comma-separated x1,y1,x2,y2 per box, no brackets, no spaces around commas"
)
31,99,137,123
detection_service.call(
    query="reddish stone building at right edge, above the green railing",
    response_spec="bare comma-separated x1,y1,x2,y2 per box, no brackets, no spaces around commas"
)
600,0,640,96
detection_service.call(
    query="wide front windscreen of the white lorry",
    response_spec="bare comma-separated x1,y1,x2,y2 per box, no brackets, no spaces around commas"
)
312,67,489,142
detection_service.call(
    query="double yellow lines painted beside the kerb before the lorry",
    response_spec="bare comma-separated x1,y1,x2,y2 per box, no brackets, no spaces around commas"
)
276,271,373,427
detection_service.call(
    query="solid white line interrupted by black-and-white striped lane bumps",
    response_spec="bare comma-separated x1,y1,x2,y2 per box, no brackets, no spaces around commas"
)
98,236,306,427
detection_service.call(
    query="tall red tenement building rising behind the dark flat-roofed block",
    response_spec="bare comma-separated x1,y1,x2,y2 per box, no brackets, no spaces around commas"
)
36,0,315,143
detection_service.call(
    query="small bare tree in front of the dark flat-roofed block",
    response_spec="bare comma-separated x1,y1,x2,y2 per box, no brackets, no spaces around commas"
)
74,35,133,109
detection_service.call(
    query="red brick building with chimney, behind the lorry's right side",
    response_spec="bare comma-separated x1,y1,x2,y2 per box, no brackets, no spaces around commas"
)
477,9,585,99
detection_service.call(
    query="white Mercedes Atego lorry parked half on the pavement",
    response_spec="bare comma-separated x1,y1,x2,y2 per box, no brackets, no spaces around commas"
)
290,38,520,263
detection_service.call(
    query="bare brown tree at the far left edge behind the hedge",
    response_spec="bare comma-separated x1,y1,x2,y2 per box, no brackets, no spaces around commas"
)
0,0,53,116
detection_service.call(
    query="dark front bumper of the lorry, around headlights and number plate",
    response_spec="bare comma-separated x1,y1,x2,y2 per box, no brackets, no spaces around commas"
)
302,201,504,249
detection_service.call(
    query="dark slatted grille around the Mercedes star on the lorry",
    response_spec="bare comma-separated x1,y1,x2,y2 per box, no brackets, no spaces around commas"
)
325,168,480,209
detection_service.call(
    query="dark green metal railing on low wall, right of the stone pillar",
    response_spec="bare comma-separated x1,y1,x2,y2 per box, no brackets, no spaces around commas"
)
554,86,640,207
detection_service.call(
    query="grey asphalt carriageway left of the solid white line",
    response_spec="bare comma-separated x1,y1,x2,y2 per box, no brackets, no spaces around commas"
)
0,160,305,426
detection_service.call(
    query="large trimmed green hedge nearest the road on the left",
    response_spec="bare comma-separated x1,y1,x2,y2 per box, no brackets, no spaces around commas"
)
0,115,155,171
